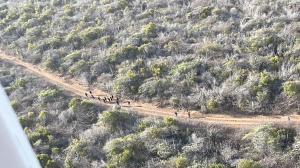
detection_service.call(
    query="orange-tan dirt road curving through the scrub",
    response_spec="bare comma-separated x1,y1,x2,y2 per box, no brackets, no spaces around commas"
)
0,51,300,127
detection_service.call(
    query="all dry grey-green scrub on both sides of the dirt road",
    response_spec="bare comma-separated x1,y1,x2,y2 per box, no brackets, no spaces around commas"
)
0,0,300,168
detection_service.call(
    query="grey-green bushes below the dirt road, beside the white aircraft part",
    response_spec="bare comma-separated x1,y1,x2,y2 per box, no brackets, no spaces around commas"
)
0,60,300,168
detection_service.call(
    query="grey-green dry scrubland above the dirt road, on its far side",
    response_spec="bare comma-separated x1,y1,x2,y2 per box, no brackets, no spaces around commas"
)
0,0,300,114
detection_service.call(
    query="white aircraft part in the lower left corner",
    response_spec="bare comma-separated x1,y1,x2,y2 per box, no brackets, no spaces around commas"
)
0,85,41,168
